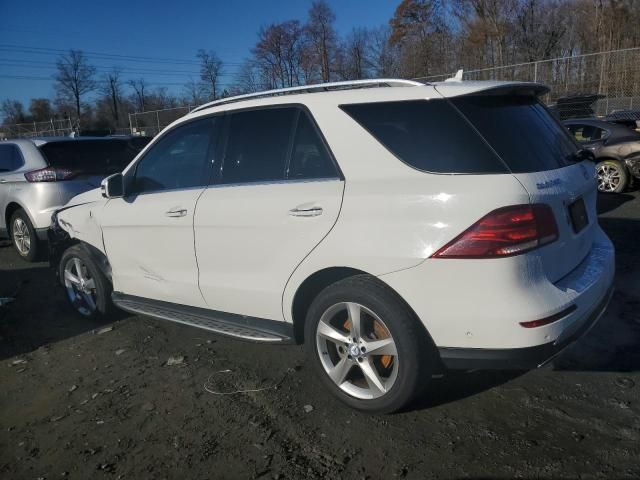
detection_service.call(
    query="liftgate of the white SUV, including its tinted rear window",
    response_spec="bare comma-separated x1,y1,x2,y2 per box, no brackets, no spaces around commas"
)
451,94,597,282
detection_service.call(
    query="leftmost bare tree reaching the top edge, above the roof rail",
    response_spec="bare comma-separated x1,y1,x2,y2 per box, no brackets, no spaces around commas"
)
305,0,337,82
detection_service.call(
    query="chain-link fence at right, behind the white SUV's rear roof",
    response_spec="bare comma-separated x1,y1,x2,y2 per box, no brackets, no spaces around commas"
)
416,47,640,120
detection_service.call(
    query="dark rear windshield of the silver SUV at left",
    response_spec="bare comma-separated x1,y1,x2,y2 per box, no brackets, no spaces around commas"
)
40,140,143,175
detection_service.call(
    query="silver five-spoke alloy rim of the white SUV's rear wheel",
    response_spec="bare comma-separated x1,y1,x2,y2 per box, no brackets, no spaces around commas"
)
316,302,399,400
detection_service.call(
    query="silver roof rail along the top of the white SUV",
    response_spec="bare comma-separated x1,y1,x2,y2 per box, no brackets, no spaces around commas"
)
190,78,425,113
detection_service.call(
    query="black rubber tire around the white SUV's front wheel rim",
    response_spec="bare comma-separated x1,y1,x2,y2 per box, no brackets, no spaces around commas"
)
58,245,114,319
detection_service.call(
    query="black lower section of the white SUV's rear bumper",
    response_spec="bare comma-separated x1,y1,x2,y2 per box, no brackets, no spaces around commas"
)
438,285,613,370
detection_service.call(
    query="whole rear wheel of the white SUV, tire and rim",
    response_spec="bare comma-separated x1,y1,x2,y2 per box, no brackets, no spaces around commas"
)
305,275,438,414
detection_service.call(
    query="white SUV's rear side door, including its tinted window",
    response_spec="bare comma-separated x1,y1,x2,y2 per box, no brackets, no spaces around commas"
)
194,106,344,320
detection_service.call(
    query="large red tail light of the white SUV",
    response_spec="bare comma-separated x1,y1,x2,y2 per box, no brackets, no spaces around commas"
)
432,204,558,258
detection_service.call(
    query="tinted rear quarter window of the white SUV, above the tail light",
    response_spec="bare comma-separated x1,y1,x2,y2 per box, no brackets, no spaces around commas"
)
340,100,507,173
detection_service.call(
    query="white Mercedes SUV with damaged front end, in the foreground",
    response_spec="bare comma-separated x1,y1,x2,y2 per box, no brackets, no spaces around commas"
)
50,80,614,412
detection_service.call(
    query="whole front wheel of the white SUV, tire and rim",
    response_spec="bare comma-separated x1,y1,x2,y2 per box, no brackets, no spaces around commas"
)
58,245,114,319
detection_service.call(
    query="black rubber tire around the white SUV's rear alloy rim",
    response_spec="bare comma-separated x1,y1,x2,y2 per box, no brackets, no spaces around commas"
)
305,275,439,414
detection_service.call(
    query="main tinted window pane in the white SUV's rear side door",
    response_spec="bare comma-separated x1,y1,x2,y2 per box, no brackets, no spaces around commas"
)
220,107,298,184
